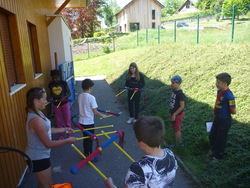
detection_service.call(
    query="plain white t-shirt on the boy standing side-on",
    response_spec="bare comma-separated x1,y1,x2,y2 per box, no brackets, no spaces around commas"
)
78,92,98,125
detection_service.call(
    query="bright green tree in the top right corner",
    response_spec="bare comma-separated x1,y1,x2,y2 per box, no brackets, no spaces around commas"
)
222,0,250,17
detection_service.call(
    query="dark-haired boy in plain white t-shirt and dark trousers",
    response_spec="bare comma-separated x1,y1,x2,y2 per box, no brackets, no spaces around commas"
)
78,79,107,162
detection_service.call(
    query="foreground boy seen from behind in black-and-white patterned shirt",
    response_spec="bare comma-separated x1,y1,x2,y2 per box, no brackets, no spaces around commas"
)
104,116,178,188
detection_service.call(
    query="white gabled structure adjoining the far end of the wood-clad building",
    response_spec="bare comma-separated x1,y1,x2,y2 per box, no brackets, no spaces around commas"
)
48,16,73,69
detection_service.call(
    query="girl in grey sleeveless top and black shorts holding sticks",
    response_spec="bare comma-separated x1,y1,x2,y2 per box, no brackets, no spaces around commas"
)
26,87,77,187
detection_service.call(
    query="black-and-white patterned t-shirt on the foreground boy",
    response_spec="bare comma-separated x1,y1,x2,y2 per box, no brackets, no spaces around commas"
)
124,148,178,188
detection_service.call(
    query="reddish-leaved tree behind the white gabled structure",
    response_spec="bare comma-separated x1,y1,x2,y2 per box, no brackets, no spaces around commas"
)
61,0,104,39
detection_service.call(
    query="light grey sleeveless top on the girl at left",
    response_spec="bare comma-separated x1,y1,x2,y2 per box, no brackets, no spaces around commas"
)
26,112,51,160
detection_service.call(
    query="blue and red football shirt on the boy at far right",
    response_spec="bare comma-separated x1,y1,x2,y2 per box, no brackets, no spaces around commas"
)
214,89,236,118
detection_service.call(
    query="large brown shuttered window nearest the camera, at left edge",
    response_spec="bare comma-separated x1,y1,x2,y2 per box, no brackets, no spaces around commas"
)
0,8,25,92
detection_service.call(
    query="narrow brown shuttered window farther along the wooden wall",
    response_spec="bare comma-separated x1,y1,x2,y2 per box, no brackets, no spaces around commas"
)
27,22,42,77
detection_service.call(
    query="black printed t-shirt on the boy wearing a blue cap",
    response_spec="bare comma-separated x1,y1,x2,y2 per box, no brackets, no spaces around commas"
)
170,89,185,114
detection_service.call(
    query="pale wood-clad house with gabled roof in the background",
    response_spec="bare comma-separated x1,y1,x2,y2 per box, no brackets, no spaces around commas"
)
115,0,164,32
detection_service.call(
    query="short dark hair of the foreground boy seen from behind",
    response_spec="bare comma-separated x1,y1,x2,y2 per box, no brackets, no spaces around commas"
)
133,116,165,147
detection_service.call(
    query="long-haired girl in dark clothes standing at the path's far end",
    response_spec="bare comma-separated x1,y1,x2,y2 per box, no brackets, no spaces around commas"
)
125,63,145,123
